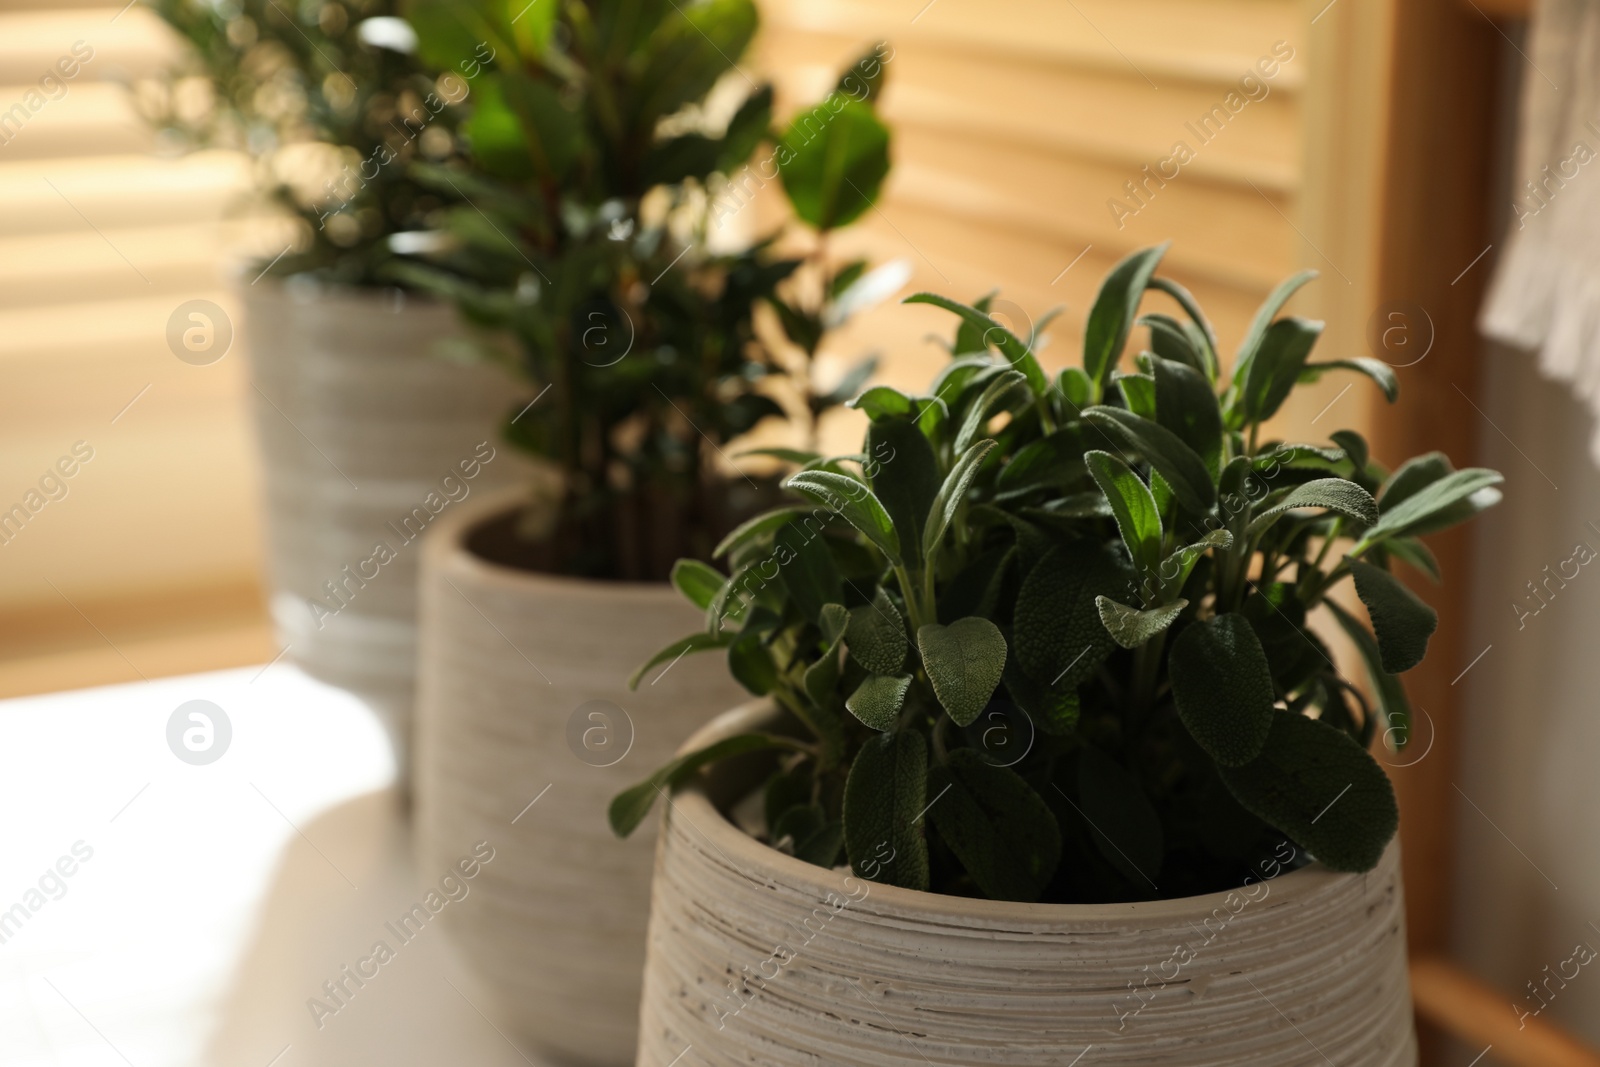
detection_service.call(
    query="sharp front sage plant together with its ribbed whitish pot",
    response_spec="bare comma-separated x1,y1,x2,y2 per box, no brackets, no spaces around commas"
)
610,246,1501,1067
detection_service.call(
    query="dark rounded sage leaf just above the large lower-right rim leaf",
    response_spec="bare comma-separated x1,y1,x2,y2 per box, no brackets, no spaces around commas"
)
1168,614,1275,766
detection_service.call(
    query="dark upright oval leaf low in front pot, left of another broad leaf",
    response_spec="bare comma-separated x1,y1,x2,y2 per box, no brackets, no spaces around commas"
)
845,729,928,889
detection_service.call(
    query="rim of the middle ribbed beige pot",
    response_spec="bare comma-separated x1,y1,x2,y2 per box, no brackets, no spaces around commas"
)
422,483,678,605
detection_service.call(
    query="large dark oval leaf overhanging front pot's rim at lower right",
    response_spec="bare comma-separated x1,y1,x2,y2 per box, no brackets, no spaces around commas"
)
1222,712,1400,873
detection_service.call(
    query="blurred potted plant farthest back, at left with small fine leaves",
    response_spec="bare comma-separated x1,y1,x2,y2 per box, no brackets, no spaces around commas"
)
136,0,526,767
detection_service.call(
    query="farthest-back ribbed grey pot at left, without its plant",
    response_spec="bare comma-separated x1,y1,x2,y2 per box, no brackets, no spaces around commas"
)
240,278,526,774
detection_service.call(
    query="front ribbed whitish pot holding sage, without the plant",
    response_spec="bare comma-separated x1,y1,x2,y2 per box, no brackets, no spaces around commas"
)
638,704,1418,1067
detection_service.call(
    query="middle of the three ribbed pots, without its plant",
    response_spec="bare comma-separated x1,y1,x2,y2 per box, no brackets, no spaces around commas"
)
416,494,742,1067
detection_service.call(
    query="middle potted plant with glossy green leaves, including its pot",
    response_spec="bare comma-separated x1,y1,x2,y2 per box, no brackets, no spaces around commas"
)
392,0,904,1064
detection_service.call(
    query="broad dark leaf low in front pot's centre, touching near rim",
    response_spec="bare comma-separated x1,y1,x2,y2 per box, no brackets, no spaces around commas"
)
928,749,1061,902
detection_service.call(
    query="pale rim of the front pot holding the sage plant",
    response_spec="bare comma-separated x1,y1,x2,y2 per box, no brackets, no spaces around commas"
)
662,699,1400,926
